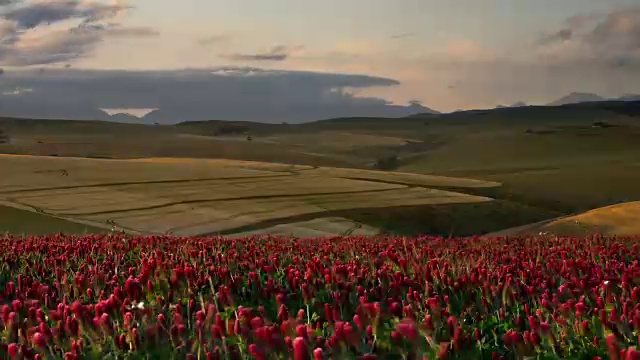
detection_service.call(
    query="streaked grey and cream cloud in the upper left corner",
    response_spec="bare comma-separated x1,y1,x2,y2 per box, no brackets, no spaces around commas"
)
0,0,159,66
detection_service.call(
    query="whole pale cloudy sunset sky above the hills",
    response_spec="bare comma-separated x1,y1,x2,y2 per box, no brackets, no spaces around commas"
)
0,0,640,121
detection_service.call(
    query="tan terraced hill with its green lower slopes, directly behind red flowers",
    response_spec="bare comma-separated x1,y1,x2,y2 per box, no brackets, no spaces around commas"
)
0,155,550,235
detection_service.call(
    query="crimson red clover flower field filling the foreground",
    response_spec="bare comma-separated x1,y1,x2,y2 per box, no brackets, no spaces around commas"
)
0,234,640,360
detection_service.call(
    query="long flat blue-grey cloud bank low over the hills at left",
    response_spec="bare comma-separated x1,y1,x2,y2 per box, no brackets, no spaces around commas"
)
0,68,430,123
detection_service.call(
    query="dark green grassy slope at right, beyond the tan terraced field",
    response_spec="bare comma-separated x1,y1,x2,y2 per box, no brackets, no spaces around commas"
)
399,128,640,213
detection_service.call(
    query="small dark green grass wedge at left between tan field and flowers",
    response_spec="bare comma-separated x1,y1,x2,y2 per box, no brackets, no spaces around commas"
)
0,205,108,235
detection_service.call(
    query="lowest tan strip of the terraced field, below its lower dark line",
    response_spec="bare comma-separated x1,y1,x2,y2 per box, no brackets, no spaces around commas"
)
82,188,491,235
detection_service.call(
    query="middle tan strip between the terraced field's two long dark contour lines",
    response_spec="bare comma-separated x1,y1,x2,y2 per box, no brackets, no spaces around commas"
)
9,176,404,216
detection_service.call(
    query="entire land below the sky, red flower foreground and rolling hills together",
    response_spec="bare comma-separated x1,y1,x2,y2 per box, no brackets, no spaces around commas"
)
0,103,640,360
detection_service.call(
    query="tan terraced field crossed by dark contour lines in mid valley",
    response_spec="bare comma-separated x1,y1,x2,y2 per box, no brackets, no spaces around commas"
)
0,155,500,235
